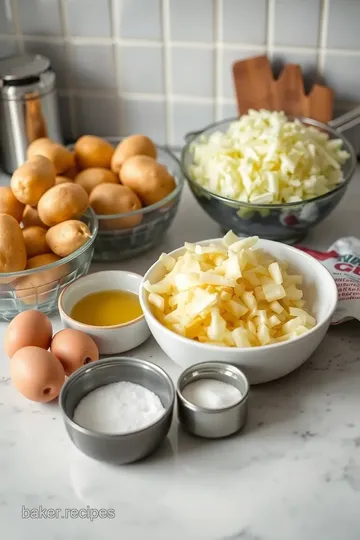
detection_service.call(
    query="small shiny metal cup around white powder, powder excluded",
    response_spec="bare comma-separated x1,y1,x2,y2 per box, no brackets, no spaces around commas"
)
176,362,249,439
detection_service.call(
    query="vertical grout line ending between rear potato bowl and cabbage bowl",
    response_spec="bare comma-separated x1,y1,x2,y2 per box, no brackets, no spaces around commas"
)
161,0,173,145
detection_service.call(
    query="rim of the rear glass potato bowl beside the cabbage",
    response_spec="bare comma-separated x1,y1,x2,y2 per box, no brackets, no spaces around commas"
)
68,142,185,221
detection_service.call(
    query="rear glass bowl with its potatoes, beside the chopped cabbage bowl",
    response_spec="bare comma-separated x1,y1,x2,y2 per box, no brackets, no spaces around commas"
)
67,135,184,261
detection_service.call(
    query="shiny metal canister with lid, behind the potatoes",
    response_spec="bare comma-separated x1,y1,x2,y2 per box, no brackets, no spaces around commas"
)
0,54,62,174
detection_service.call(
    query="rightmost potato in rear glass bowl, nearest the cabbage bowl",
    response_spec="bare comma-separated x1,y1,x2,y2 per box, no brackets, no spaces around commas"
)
120,156,176,206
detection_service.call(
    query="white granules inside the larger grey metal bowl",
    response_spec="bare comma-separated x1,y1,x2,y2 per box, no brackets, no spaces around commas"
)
73,381,165,434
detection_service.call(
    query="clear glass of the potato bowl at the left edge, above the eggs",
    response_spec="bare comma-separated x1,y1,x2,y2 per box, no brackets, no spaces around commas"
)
0,209,98,321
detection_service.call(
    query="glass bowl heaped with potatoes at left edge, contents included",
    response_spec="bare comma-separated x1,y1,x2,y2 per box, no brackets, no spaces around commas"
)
0,139,98,321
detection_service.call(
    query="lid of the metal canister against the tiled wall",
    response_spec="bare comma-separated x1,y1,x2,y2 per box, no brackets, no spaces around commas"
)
0,54,50,85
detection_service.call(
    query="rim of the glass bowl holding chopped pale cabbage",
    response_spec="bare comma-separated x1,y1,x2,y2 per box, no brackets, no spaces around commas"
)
180,114,357,210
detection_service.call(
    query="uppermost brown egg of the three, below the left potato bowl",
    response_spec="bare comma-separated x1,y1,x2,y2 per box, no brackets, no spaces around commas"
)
4,310,53,358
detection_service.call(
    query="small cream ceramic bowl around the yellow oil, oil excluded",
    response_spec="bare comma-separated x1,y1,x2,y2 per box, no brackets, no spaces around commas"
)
59,270,150,354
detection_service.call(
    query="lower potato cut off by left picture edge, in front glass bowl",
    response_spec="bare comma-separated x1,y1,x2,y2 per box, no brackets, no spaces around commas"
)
0,214,26,273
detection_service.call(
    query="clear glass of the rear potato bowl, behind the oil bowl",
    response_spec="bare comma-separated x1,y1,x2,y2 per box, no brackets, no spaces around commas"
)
94,143,184,261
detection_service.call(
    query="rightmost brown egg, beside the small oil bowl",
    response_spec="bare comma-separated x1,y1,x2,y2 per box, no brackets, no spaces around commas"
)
50,328,99,375
